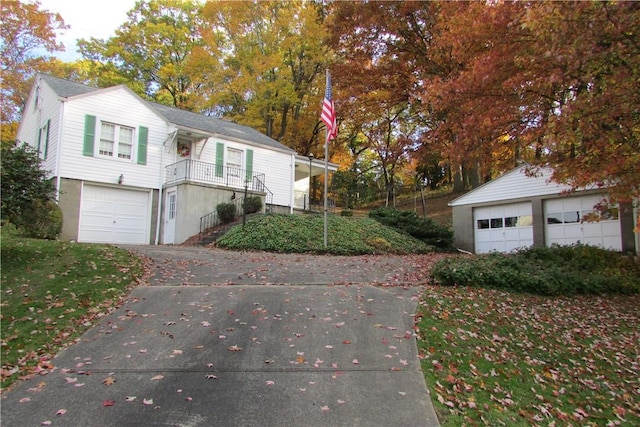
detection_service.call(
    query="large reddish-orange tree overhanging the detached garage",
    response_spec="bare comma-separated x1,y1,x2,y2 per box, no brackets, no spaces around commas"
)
422,2,640,206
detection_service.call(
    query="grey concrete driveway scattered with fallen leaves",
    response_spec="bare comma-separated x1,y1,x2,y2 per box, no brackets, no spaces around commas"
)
1,247,438,426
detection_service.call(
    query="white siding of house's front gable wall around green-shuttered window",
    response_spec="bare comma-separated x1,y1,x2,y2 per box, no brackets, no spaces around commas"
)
60,87,167,188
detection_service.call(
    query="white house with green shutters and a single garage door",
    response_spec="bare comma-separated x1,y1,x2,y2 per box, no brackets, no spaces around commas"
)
17,75,336,244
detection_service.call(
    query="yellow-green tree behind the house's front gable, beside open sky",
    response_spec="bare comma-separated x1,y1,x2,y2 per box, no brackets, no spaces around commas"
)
78,0,204,111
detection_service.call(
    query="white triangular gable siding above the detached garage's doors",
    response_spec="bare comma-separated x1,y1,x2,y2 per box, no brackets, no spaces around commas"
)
449,167,570,206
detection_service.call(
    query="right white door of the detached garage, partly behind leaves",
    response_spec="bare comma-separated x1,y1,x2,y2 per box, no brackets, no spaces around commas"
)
544,196,622,251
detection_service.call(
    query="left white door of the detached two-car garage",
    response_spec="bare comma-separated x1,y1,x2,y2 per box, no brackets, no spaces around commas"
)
473,202,533,254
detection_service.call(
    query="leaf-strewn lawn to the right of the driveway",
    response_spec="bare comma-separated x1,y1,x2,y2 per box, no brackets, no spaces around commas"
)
418,286,640,427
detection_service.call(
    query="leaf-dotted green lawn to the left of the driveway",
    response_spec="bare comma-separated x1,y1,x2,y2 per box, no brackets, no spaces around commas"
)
0,226,142,389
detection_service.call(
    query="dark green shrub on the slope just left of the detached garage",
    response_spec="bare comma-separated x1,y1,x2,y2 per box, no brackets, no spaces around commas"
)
369,207,453,248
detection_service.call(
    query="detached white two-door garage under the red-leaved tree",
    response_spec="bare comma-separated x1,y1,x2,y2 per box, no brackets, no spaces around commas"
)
449,166,639,253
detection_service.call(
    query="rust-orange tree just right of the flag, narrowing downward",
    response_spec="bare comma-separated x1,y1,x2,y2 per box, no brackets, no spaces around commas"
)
327,2,439,203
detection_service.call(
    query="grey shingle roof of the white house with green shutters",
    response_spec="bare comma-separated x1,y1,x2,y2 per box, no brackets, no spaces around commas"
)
41,74,295,153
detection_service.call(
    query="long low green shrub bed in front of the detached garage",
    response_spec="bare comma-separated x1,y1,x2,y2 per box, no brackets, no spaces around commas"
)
431,245,640,295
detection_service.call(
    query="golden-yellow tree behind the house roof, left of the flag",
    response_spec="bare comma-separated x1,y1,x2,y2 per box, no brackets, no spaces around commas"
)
202,1,326,154
